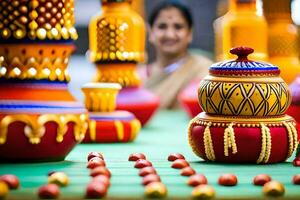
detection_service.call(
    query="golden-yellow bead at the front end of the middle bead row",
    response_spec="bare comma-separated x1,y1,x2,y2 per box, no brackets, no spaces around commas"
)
145,182,168,198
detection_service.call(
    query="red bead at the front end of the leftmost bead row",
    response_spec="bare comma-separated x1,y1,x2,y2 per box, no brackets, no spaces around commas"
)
85,181,107,199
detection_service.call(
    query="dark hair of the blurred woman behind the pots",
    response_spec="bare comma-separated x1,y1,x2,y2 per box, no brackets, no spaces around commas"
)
148,0,193,28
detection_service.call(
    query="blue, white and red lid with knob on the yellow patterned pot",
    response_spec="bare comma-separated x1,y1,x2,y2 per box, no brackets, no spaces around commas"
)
209,47,280,77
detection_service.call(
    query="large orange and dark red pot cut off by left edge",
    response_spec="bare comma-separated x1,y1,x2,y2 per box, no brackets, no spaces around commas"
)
0,0,87,162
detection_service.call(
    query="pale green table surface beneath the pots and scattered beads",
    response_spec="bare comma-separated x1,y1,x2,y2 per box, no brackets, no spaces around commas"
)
0,111,300,199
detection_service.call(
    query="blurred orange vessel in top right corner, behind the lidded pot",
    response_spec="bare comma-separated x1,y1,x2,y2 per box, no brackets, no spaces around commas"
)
263,0,300,84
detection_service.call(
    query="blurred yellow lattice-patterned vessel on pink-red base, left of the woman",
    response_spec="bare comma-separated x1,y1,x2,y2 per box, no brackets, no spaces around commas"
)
89,0,159,125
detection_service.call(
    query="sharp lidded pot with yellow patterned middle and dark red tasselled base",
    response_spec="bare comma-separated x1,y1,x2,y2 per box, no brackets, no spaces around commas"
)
188,47,298,163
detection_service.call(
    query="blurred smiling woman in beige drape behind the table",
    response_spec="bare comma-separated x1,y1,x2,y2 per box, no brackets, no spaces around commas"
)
145,1,212,108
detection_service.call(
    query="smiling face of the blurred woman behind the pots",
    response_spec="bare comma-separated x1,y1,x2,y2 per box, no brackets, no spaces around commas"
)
149,8,192,56
